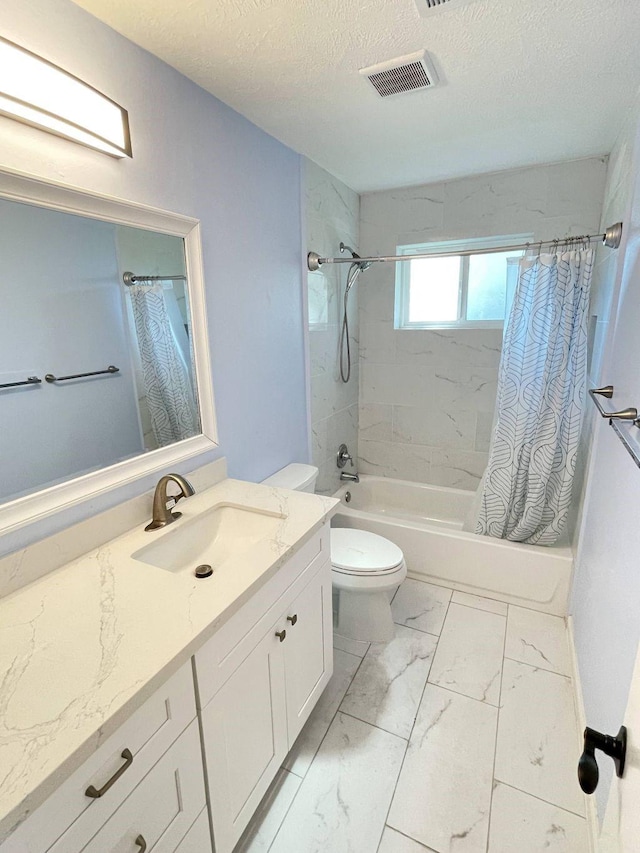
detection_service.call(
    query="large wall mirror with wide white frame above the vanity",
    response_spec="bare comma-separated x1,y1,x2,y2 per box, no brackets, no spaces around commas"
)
0,172,216,531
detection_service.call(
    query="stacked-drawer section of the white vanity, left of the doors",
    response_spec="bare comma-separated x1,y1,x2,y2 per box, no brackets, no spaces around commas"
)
0,663,211,853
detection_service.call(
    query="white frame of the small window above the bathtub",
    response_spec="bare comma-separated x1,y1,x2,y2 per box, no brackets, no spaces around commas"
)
393,234,534,331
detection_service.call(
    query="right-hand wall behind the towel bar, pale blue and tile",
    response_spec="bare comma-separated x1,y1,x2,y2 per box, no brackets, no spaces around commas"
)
570,106,640,819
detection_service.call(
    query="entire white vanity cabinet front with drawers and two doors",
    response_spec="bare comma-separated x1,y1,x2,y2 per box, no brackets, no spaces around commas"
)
0,523,333,853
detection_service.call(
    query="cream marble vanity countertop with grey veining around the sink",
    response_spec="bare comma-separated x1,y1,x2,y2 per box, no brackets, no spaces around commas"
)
0,480,338,841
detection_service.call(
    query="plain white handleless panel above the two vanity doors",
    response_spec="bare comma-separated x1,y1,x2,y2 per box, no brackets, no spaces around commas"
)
194,524,330,708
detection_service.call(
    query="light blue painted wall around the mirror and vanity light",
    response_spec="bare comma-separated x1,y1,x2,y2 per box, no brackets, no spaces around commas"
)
0,0,307,554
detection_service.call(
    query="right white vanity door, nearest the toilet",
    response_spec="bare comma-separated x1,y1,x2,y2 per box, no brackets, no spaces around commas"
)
282,563,333,747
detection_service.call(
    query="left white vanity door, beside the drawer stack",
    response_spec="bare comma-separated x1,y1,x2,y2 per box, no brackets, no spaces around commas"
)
202,625,287,853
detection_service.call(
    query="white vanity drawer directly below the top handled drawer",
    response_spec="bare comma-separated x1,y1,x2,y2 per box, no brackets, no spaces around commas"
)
51,721,206,853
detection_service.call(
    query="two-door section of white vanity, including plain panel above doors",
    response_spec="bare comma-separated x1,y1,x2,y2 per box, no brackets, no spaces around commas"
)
195,528,333,853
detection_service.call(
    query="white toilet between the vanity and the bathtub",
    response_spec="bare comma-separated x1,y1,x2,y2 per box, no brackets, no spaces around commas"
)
263,463,407,643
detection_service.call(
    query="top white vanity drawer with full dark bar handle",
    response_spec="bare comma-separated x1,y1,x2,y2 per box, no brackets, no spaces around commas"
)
1,663,196,853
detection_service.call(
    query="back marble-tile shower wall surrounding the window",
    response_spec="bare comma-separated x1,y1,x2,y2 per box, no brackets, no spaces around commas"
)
358,158,607,489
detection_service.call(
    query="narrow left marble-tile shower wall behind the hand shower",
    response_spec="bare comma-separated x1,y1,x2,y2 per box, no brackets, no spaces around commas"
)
305,160,360,494
